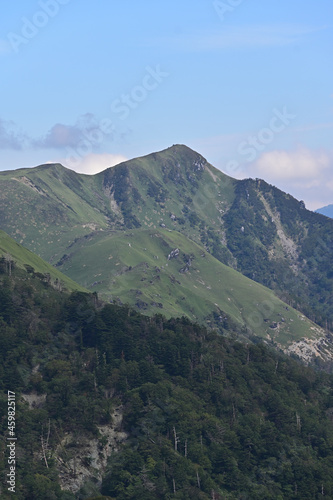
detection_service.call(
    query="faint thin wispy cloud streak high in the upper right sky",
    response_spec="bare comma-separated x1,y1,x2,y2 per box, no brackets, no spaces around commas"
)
150,24,326,52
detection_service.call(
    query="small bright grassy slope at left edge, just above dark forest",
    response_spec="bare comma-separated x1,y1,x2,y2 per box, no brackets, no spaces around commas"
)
0,230,87,291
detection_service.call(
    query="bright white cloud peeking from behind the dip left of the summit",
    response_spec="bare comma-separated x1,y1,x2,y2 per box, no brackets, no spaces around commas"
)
60,153,128,175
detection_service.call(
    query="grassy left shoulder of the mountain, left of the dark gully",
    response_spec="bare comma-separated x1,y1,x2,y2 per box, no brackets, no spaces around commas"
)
0,165,107,263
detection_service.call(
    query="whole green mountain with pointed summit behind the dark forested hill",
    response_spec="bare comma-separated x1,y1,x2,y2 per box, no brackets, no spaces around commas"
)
0,145,333,355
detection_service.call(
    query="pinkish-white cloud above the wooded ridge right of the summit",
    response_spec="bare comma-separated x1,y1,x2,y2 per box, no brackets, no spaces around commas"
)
249,149,331,181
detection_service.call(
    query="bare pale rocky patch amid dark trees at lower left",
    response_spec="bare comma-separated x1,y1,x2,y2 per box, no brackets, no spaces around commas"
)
55,407,127,493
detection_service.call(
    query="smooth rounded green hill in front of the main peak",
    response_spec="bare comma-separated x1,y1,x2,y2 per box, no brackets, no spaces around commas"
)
55,229,318,346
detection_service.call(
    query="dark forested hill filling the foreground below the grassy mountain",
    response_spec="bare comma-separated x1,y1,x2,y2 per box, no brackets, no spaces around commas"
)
0,260,333,500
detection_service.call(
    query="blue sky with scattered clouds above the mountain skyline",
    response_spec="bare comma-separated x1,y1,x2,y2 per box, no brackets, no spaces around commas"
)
0,0,333,209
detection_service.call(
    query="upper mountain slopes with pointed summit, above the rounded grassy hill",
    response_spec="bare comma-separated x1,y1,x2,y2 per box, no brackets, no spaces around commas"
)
0,146,236,264
